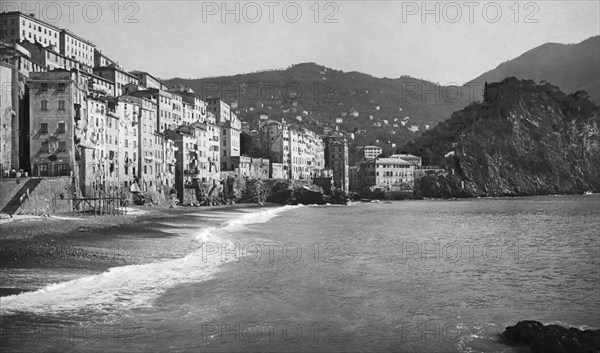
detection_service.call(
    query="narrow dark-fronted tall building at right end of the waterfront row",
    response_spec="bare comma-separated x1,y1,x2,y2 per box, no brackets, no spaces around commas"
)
323,134,350,192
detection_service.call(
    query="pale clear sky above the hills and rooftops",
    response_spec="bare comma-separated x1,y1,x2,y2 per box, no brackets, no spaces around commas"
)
0,0,600,85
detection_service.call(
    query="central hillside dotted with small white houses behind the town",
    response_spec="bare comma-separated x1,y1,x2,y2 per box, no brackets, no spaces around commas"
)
166,63,468,150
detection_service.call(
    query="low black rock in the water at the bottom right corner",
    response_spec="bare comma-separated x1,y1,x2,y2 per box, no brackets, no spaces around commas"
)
502,321,600,353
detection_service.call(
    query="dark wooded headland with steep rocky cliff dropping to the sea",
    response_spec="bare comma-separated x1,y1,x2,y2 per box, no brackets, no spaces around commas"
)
406,77,600,197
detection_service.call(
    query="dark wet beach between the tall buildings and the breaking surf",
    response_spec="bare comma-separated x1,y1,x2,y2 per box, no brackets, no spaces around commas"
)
0,204,279,296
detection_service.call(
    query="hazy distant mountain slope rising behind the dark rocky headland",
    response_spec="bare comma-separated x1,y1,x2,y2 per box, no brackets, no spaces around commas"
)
471,36,600,104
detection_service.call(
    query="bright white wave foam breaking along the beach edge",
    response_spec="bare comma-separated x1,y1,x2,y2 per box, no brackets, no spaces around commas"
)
0,206,297,314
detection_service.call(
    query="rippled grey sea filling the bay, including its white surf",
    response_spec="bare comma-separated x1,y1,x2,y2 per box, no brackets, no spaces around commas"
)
0,194,600,353
